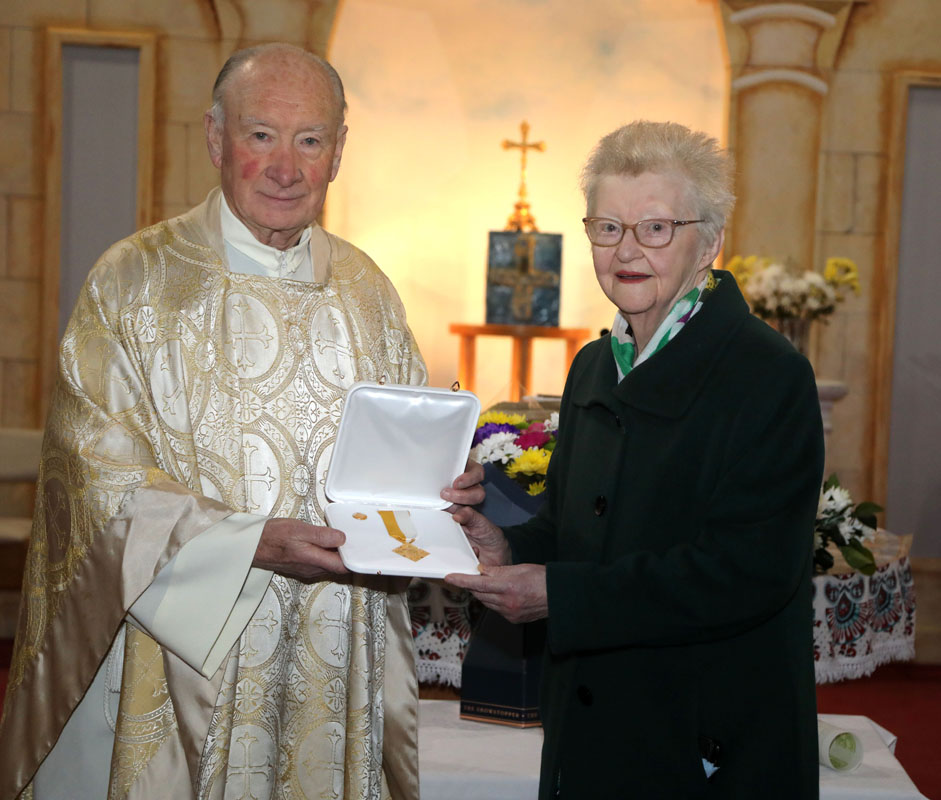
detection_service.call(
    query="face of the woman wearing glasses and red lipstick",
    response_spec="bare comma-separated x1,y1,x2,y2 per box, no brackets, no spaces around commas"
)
589,172,723,347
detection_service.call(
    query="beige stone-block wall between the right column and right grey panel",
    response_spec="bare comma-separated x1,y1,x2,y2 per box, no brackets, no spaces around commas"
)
815,0,941,512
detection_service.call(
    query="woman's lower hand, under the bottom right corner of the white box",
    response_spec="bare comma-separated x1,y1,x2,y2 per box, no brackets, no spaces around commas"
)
444,564,549,622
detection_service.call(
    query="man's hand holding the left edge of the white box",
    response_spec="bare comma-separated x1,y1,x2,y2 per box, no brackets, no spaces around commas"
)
252,517,349,582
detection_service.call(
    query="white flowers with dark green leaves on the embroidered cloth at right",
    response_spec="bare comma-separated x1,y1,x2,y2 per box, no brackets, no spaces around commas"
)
814,475,882,575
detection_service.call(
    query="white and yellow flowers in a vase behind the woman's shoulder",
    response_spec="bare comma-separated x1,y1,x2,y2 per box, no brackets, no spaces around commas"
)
726,256,860,352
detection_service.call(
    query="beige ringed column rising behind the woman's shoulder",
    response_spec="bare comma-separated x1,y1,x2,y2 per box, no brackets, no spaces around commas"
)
719,0,860,271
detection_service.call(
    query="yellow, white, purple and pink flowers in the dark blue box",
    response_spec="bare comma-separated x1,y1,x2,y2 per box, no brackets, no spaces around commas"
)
471,411,559,496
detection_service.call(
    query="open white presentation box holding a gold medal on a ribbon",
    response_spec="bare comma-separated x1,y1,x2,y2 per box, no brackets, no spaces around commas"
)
324,382,480,578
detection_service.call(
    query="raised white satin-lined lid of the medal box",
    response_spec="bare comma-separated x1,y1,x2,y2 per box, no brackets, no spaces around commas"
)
325,382,480,509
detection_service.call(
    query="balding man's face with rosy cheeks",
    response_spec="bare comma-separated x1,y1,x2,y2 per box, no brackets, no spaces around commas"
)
205,52,346,250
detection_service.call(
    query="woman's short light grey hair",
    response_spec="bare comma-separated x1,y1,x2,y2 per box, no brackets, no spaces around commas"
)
581,120,735,241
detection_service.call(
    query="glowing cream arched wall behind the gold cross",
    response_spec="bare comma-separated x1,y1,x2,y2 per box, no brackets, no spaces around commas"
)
325,0,726,407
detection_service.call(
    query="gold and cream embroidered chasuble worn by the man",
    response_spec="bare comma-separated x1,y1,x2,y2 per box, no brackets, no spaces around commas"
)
0,190,426,800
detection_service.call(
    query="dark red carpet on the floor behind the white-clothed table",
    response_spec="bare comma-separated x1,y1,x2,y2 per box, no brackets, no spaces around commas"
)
0,639,941,800
